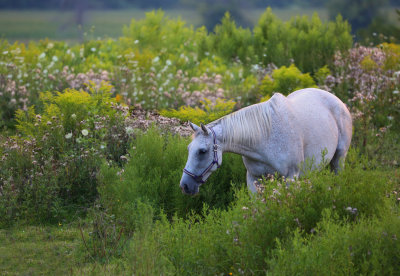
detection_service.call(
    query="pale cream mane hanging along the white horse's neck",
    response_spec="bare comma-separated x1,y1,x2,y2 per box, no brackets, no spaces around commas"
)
210,99,275,147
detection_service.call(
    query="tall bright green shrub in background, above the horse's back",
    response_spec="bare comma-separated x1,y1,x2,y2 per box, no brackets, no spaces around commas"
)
254,8,352,73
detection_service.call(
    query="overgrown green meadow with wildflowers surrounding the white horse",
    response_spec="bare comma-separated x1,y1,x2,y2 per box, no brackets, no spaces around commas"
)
0,5,400,275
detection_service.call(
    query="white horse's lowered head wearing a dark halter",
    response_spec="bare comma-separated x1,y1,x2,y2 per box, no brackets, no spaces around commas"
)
180,122,222,195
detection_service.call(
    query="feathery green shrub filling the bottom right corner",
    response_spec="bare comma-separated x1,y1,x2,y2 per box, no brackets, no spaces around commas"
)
268,209,400,275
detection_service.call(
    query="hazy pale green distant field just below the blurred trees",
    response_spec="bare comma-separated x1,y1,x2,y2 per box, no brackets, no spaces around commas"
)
0,8,327,42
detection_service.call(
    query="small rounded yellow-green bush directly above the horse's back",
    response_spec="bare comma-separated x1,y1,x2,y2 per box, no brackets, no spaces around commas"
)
260,64,317,96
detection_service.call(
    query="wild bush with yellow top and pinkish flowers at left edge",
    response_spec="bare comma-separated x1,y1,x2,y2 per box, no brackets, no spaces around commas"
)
0,84,129,224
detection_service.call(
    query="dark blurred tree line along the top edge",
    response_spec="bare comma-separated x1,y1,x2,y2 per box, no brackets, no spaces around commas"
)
0,0,400,42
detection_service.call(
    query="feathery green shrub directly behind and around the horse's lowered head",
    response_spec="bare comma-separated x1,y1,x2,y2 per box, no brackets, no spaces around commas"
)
99,126,246,228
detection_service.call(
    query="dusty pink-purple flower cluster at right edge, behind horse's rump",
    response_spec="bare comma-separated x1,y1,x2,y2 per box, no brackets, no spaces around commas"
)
324,46,400,125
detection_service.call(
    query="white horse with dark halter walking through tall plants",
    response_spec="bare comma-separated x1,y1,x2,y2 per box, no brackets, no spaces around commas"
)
180,88,352,195
